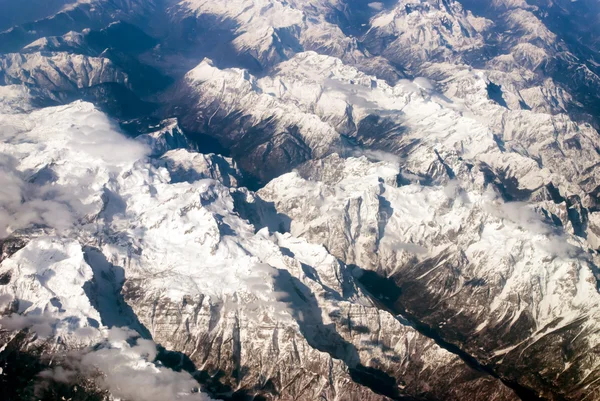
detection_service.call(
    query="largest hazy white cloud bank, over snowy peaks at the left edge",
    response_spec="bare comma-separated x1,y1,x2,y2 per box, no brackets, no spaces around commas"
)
0,102,147,238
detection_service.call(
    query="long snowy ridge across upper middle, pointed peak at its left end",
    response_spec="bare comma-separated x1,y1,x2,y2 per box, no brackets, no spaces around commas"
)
176,52,600,247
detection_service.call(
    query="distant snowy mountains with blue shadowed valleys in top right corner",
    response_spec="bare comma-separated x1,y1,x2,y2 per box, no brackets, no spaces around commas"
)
362,0,600,125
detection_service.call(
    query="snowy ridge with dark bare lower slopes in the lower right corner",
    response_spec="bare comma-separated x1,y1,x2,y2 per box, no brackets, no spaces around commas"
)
259,155,600,399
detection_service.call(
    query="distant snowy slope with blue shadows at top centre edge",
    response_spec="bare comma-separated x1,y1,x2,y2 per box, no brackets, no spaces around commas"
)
170,0,402,81
